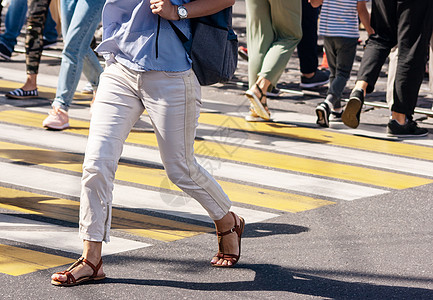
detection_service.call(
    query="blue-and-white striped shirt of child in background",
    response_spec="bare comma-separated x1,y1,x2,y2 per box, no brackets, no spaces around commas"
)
319,0,368,38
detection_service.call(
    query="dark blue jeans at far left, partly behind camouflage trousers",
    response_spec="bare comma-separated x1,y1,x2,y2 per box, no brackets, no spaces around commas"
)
0,0,57,52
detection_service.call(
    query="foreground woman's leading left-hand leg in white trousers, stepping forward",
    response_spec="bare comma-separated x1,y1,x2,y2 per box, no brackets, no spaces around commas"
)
52,64,144,281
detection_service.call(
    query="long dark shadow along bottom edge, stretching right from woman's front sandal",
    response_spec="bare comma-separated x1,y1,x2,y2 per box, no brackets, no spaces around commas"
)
103,264,433,299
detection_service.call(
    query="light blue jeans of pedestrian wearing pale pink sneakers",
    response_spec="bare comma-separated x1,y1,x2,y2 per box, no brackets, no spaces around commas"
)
53,0,105,111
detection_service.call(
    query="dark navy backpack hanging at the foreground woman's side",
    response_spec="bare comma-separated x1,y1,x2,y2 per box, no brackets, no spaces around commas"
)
168,7,238,85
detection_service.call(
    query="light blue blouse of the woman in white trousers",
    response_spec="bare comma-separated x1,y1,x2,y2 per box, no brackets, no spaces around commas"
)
96,0,191,72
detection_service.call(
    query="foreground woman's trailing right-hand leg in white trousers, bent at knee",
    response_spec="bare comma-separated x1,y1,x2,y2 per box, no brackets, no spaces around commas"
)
140,70,240,265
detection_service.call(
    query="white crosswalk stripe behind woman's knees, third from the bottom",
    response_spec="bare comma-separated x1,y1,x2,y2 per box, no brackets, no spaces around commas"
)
0,126,387,201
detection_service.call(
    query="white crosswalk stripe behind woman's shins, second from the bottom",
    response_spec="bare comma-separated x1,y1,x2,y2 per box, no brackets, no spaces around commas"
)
0,162,279,223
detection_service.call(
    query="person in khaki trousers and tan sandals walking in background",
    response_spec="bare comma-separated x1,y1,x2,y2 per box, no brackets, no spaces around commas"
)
245,0,302,121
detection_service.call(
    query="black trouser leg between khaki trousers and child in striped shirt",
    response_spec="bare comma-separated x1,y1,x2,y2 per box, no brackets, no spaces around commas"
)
297,0,319,74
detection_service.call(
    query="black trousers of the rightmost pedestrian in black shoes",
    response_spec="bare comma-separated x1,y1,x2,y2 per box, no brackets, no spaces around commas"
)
358,0,433,119
